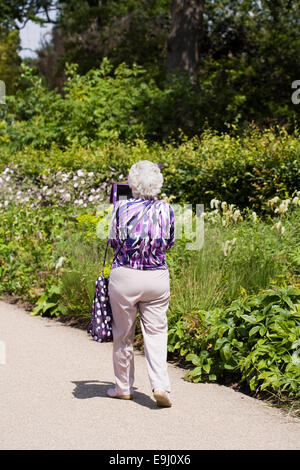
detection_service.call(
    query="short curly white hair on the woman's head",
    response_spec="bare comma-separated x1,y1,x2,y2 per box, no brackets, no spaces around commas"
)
128,160,164,199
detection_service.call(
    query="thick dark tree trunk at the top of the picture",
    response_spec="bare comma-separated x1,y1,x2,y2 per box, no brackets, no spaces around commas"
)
166,0,205,83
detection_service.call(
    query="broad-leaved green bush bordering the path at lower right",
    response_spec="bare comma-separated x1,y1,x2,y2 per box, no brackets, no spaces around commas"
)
169,286,300,397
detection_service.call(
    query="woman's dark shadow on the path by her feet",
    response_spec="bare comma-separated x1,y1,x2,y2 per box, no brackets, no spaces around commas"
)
72,380,161,410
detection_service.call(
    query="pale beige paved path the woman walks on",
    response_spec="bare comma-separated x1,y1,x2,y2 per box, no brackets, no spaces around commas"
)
0,302,300,450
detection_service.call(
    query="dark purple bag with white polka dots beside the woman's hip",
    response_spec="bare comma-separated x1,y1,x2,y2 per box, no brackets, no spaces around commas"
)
87,276,113,343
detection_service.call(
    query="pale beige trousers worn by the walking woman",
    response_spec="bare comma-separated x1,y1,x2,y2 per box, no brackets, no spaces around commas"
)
108,266,170,395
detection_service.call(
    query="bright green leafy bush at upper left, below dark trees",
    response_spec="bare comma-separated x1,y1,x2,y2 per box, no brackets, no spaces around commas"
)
1,59,169,151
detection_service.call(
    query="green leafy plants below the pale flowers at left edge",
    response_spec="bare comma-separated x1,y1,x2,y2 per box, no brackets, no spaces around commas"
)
0,203,86,302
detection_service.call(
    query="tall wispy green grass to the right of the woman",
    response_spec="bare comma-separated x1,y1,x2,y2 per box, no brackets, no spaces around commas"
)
168,209,300,324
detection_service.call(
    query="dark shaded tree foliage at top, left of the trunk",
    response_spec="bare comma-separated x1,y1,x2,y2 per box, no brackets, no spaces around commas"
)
31,0,171,87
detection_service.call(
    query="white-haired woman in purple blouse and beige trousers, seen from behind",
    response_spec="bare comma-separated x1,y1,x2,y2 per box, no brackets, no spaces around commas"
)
107,160,175,407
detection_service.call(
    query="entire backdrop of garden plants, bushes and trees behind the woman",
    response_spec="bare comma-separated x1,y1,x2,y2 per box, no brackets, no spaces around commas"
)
0,0,300,406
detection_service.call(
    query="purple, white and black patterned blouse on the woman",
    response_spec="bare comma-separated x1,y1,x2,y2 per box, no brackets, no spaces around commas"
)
108,198,175,270
